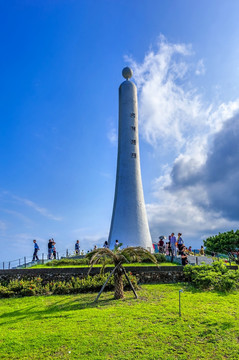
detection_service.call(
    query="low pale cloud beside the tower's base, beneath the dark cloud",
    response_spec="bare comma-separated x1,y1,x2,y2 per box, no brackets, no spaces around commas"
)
147,192,238,243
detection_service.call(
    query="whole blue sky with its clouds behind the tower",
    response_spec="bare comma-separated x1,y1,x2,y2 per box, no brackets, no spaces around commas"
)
0,0,239,261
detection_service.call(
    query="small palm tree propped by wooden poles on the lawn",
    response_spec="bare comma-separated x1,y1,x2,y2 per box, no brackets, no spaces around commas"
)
87,247,157,300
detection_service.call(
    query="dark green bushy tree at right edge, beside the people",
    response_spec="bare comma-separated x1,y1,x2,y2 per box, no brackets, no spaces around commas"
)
203,230,239,254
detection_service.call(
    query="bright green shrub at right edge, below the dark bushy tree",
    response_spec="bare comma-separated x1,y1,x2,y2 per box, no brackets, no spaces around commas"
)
184,261,239,292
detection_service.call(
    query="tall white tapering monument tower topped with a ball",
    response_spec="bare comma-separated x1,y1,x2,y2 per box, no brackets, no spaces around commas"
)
109,67,152,251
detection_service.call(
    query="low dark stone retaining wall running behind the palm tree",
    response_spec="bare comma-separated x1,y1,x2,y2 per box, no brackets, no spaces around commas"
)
0,266,185,284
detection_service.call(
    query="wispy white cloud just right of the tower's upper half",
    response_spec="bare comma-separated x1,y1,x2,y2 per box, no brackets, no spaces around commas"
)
127,37,210,150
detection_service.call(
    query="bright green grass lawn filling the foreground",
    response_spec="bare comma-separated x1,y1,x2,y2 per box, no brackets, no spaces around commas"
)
0,284,239,360
